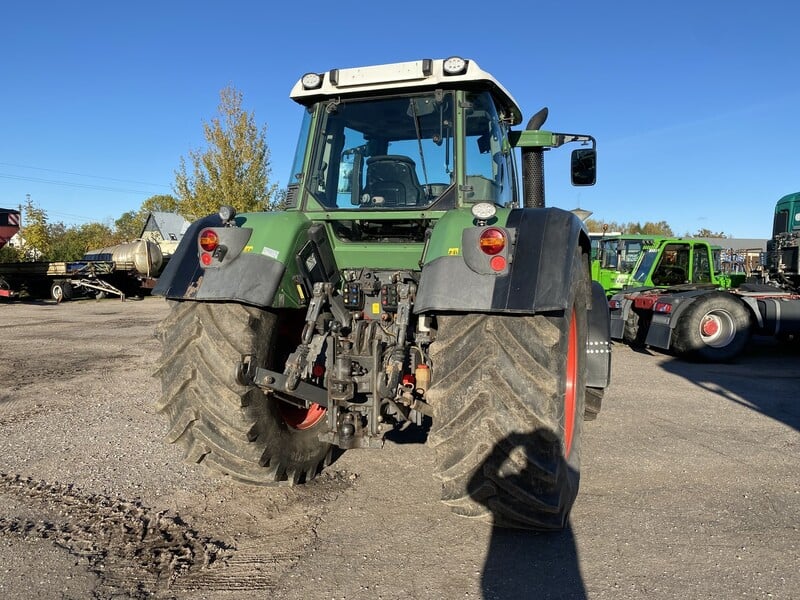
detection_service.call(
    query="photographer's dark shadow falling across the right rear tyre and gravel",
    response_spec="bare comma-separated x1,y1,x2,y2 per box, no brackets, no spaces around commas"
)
468,430,586,600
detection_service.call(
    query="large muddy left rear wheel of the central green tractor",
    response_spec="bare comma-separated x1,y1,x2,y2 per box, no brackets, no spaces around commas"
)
157,302,330,485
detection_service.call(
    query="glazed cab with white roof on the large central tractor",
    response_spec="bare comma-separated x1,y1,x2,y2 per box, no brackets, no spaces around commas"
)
288,59,521,213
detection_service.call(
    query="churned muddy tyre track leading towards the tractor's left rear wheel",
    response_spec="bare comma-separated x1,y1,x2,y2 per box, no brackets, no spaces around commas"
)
0,472,354,600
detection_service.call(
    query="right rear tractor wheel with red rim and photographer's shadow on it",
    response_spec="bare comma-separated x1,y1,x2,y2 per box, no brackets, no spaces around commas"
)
427,248,589,530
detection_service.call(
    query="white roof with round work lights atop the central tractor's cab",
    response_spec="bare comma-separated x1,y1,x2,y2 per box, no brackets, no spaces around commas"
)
289,57,522,125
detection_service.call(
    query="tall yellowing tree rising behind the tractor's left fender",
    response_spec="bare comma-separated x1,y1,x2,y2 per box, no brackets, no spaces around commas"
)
174,86,277,218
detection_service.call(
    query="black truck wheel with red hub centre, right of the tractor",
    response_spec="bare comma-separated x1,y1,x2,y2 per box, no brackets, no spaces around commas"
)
671,292,752,362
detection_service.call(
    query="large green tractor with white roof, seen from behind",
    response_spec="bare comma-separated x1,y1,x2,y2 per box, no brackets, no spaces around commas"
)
154,57,610,529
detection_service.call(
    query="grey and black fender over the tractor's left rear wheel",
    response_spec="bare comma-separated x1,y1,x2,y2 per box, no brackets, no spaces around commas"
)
152,214,286,306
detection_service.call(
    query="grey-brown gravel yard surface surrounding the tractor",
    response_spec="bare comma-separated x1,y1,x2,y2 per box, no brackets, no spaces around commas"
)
0,298,800,600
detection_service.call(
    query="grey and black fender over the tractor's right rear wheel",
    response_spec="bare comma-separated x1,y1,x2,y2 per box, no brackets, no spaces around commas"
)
414,208,590,314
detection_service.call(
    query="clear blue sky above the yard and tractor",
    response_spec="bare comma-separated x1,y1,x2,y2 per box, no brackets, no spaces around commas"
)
0,0,800,238
